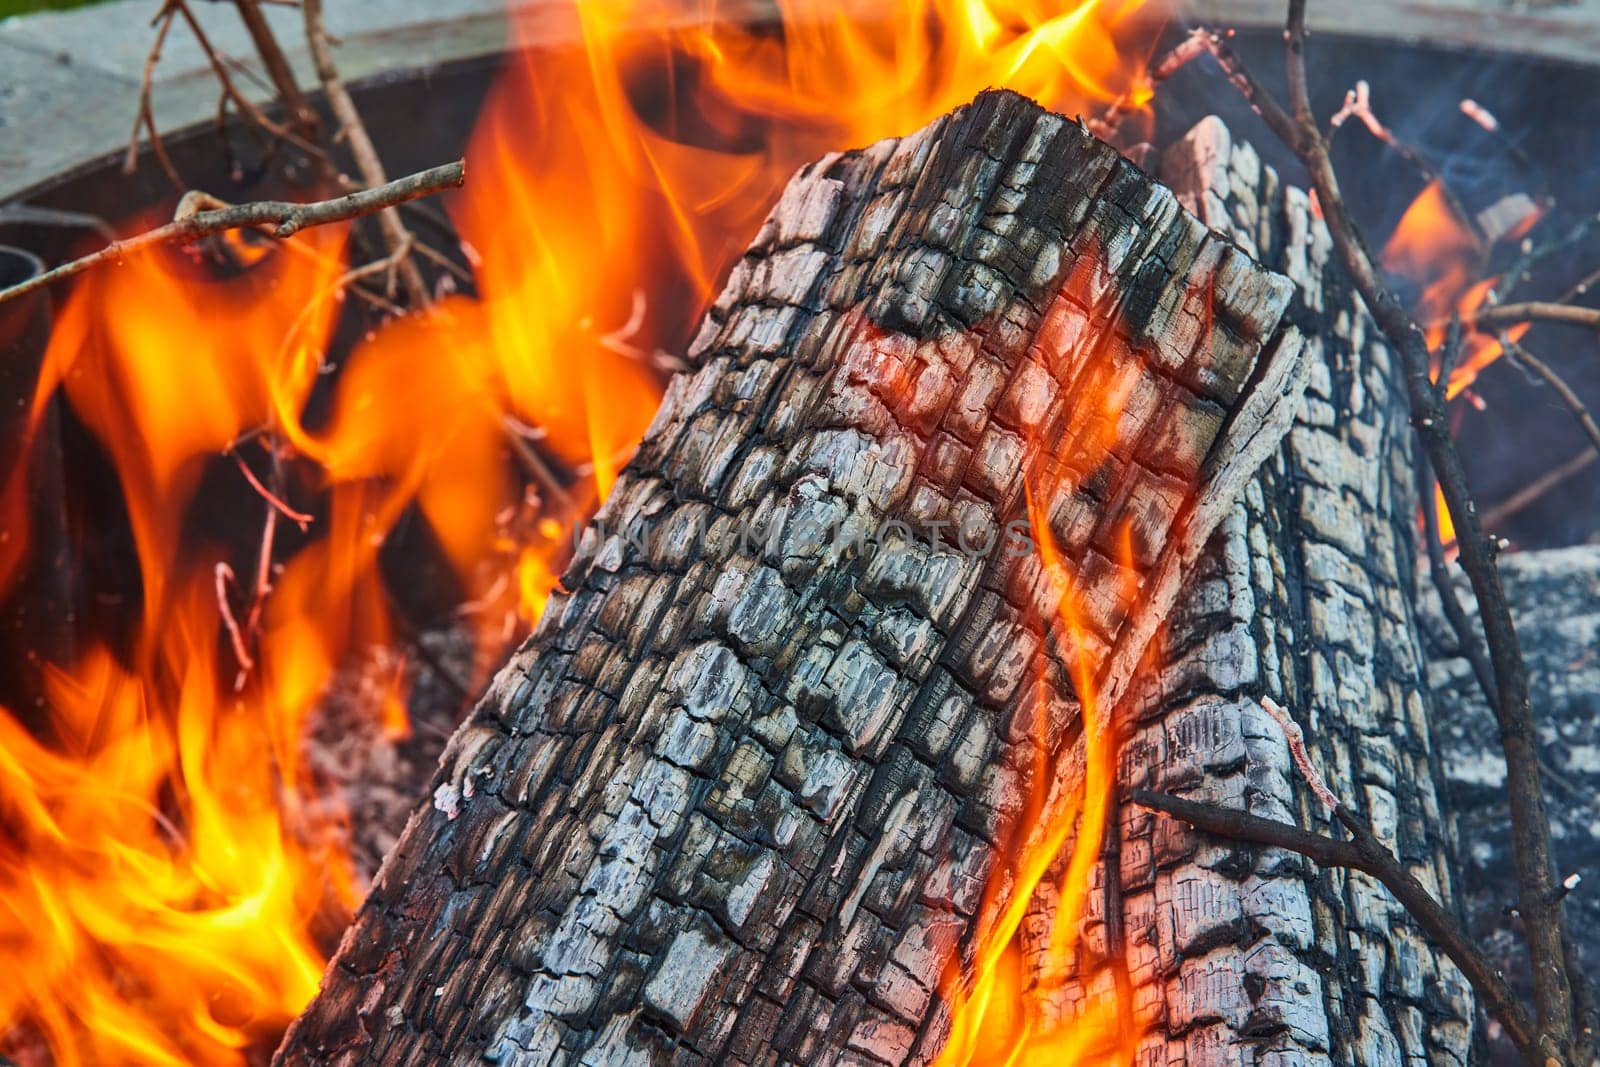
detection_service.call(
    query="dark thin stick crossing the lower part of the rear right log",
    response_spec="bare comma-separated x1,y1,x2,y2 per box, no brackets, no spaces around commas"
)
1128,789,1544,1064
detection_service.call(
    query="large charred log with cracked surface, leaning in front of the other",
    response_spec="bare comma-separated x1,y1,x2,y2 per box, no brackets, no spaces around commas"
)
278,93,1305,1064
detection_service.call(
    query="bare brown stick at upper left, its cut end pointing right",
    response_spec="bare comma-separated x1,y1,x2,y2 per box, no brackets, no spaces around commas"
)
0,160,467,304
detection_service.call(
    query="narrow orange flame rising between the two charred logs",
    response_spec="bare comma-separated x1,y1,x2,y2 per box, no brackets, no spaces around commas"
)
938,287,1144,1067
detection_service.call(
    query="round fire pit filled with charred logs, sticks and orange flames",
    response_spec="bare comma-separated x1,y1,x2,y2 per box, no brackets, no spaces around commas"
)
0,0,1600,1064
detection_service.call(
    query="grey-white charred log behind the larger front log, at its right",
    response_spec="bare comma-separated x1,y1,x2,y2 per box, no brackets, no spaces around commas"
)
1027,118,1474,1067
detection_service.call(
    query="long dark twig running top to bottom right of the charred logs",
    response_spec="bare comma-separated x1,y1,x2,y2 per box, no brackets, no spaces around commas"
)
1273,0,1573,1062
